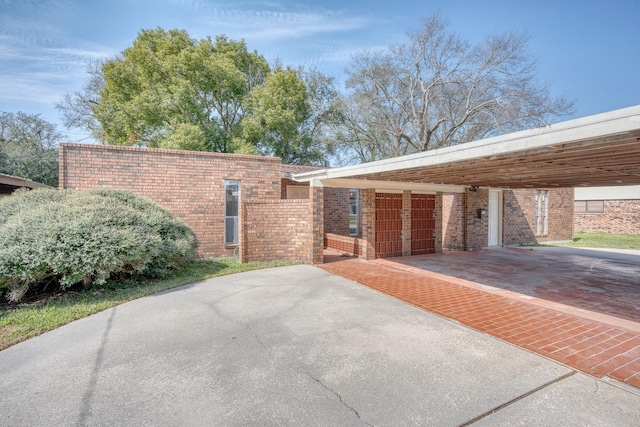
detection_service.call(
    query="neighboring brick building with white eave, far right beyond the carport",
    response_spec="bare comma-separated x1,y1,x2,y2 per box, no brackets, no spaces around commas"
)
574,185,640,234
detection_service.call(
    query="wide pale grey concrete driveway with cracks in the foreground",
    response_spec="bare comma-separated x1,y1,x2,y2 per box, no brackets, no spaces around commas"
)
0,266,640,426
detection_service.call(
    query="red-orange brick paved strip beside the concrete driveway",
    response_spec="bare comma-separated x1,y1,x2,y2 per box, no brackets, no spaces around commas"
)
319,259,640,388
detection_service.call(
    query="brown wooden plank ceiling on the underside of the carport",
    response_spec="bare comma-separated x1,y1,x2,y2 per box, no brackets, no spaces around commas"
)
350,131,640,188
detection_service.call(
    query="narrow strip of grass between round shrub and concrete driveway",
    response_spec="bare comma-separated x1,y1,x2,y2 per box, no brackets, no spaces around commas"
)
0,259,290,350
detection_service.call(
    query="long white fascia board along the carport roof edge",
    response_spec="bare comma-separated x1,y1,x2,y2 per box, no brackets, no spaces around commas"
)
294,105,640,182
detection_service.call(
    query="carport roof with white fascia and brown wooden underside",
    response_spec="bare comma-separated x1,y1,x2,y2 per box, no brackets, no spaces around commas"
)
294,105,640,188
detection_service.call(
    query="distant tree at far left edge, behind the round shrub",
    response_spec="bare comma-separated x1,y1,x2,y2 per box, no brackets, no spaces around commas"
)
0,112,62,186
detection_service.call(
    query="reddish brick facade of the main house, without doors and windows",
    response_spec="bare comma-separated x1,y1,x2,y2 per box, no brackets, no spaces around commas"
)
59,144,576,263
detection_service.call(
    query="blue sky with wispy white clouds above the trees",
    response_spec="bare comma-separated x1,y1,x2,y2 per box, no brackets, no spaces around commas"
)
0,0,640,141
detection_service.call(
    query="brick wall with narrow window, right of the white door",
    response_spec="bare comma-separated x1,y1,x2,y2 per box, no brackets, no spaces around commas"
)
502,188,573,245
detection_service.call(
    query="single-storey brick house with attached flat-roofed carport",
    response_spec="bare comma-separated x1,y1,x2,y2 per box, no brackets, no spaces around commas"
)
59,106,640,263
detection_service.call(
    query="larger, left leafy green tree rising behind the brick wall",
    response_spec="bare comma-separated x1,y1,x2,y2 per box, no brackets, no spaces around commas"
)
93,28,269,152
